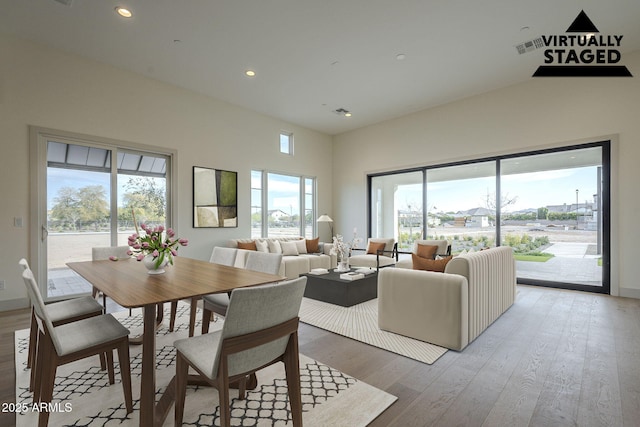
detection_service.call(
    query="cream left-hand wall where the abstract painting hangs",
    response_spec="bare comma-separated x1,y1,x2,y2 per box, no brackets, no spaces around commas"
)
0,33,332,310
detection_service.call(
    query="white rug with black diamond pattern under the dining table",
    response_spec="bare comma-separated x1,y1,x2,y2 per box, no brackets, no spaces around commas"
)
15,303,396,427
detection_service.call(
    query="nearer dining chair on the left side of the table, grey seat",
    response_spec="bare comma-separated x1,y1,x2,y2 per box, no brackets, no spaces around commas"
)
22,268,133,427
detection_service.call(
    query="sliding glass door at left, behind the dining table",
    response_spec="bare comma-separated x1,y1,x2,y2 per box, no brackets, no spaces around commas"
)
31,129,170,299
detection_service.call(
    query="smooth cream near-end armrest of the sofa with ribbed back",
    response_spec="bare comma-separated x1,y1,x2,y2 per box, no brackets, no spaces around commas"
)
378,268,469,350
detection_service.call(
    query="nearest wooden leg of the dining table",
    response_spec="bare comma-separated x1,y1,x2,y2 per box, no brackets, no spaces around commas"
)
140,304,156,427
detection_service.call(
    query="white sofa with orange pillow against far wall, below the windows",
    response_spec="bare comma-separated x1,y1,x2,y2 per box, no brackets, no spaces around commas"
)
229,237,337,279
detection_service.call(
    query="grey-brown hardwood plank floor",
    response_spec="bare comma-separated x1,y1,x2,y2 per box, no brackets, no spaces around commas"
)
0,286,640,427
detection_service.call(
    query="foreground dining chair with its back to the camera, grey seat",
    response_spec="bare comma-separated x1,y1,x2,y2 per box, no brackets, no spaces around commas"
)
174,277,307,426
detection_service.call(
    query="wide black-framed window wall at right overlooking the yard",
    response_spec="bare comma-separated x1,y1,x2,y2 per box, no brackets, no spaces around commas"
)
369,141,610,293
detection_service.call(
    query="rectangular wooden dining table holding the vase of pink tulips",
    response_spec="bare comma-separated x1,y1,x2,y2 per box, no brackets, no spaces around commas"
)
67,257,285,427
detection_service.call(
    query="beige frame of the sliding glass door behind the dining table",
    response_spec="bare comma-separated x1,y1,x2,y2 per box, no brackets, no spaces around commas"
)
29,126,178,301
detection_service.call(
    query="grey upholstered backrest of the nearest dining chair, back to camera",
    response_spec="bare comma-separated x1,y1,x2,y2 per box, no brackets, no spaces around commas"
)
211,277,307,378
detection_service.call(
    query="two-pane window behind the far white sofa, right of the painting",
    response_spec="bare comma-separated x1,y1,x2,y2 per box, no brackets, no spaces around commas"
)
251,170,316,238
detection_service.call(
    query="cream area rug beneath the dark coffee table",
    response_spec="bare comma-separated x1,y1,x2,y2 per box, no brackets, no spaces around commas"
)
300,298,447,365
